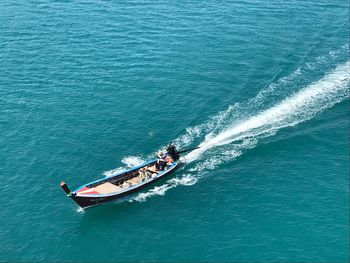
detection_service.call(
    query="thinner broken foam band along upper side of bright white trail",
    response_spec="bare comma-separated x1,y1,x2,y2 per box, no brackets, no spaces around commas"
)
174,44,349,152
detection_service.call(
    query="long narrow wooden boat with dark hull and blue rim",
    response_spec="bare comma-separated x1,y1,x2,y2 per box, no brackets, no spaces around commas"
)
61,159,181,209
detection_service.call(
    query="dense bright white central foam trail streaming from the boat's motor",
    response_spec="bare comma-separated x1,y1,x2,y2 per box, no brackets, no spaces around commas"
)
185,61,350,162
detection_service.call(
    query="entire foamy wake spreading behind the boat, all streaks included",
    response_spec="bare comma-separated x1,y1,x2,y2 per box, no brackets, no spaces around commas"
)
105,46,350,202
